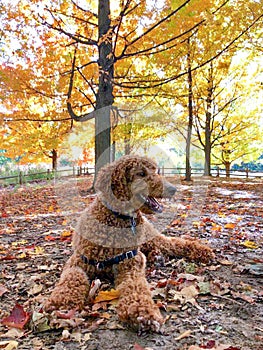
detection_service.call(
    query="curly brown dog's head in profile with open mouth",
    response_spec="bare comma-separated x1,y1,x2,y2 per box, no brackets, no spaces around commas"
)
95,155,176,214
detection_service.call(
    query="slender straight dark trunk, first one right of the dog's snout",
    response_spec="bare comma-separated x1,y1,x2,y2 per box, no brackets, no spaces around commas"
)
185,38,193,181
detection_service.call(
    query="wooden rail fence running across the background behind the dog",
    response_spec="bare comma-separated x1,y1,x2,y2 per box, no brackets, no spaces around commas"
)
0,167,263,186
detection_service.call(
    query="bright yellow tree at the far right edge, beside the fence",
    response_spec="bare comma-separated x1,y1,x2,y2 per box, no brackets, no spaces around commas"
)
212,54,263,176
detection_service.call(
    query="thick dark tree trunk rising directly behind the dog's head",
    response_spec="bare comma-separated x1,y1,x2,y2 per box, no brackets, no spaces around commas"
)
95,0,114,177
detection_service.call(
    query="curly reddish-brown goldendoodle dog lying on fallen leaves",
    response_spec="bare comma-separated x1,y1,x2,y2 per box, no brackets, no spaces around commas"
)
44,155,214,331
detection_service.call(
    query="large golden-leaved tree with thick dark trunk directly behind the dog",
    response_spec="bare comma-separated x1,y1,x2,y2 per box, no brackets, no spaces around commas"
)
2,0,262,178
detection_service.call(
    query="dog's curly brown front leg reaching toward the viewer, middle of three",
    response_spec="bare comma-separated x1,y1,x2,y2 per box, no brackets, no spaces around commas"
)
115,252,164,332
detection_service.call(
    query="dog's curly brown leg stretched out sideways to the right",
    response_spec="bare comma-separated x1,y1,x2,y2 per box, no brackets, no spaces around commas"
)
141,234,215,263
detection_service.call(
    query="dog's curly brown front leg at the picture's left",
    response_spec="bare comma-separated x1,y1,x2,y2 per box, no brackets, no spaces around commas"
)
44,255,90,311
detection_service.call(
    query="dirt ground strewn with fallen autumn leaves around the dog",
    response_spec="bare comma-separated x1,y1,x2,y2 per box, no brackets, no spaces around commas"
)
0,178,263,350
